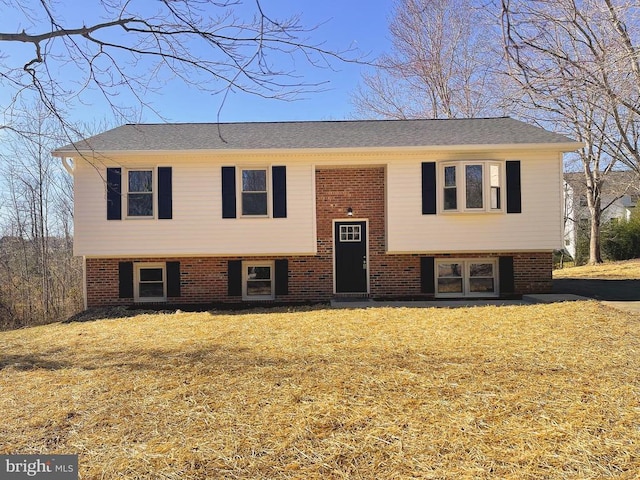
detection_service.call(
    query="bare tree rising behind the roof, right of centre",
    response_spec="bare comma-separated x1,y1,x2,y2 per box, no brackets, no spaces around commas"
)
353,0,503,118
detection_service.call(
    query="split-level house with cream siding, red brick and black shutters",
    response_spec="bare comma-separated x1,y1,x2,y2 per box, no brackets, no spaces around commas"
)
54,118,580,307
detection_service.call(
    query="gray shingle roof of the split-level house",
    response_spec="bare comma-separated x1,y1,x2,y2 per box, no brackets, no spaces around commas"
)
54,117,577,155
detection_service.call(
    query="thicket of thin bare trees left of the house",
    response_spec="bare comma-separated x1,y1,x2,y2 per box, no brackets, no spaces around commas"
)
0,103,82,326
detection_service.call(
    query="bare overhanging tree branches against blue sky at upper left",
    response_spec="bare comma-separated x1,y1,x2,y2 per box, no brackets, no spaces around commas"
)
0,0,356,133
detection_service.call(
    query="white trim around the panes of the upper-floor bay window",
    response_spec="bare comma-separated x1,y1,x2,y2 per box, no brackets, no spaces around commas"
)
438,160,506,215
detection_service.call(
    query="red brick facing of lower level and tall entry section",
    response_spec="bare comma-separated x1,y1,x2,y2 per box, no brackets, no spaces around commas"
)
86,167,552,307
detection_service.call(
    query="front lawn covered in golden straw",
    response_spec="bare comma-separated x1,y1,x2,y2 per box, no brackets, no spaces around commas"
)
0,301,640,479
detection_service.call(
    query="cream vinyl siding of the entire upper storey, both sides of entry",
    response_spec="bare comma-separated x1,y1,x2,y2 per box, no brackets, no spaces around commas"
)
67,149,562,256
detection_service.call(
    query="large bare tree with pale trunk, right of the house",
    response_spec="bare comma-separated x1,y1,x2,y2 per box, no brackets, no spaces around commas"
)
501,0,640,263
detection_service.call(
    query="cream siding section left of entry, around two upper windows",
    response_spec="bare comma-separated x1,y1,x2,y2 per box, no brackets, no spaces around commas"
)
74,156,315,256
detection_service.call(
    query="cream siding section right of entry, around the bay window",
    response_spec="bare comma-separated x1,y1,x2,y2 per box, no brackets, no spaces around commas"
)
387,152,562,253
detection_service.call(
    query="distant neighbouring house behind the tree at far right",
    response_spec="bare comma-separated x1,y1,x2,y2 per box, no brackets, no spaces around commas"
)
564,170,640,259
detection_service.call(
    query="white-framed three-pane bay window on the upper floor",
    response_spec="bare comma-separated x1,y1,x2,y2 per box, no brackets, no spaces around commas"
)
439,161,504,213
